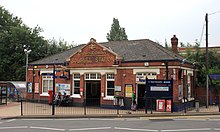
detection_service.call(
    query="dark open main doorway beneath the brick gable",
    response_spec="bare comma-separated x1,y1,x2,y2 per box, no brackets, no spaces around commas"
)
86,80,101,106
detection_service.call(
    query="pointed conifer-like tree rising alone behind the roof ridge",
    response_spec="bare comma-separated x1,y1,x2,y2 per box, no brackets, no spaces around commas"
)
106,18,128,41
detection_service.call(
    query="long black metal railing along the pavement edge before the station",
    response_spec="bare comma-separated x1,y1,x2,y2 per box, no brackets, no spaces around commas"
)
21,98,219,115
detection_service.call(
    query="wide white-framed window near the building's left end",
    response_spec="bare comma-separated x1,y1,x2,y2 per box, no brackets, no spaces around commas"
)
42,76,53,93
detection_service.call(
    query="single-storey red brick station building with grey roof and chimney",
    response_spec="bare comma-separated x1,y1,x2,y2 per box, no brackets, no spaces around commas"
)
26,35,195,108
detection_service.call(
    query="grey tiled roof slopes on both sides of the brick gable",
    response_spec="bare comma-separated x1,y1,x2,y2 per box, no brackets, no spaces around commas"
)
30,39,184,65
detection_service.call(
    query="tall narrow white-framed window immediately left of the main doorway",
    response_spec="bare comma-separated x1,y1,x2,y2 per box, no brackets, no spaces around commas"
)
73,74,80,95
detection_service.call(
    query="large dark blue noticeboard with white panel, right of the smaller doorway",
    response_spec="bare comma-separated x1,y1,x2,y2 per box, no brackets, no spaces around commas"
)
145,79,173,98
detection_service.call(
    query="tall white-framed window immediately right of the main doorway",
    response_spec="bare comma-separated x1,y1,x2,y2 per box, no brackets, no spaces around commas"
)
106,73,115,96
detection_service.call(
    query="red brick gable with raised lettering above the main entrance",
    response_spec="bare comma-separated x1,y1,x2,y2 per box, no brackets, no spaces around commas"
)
69,41,117,67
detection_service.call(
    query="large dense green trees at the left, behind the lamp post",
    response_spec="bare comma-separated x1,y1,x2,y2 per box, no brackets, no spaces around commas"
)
0,6,71,81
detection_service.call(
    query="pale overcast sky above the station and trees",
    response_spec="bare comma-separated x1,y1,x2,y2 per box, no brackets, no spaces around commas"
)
0,0,220,47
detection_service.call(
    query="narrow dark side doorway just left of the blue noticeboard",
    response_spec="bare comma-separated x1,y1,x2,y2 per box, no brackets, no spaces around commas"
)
137,84,146,109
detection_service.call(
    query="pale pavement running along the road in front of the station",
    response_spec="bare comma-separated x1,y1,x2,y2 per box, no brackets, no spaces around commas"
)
0,102,220,119
